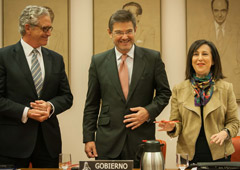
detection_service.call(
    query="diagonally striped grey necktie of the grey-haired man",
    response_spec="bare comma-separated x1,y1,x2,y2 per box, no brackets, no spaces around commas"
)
31,49,43,98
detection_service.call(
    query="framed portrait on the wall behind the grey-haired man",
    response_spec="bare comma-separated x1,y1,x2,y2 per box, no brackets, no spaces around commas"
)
2,0,69,75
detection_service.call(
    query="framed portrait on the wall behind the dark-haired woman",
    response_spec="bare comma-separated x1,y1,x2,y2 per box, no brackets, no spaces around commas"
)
186,0,240,102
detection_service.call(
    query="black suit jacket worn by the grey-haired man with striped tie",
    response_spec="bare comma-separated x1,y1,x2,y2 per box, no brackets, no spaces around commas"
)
0,42,73,158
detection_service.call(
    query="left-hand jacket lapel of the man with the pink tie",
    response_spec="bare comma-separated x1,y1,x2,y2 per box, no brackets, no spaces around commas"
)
106,48,126,101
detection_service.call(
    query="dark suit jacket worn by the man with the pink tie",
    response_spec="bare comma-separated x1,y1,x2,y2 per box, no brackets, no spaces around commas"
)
83,46,171,158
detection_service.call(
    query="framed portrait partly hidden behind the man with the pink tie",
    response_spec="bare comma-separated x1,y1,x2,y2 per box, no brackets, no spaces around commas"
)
93,0,161,54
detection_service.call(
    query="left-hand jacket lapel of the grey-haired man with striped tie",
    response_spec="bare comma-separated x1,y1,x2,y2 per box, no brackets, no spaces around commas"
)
14,41,37,96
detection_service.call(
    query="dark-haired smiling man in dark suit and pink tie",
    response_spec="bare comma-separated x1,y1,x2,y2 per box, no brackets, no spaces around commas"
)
83,10,171,168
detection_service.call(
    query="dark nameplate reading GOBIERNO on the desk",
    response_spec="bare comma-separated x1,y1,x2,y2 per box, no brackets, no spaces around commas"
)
79,160,133,170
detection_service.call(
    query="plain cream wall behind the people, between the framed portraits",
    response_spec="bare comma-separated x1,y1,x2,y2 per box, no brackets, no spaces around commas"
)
0,0,239,168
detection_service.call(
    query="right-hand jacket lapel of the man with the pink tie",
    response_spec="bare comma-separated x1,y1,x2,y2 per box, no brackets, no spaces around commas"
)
127,46,145,100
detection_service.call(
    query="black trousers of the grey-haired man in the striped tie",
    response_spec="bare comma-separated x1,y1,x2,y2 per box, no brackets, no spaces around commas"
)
0,125,58,168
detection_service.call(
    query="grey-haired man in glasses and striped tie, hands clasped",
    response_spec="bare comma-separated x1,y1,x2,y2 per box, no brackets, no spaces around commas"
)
0,6,73,168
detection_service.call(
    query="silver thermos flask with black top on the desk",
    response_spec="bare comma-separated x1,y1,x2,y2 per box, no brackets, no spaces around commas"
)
140,140,165,170
